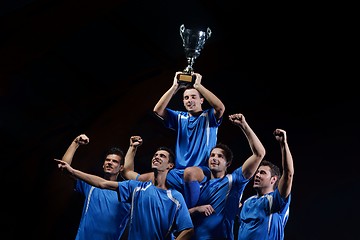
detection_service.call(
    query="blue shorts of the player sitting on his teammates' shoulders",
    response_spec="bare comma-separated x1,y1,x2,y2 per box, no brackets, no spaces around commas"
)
166,166,211,194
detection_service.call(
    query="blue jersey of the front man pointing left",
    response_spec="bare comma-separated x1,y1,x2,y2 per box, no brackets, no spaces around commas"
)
119,180,193,240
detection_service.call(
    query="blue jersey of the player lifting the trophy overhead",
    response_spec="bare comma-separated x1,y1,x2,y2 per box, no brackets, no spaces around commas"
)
164,108,222,169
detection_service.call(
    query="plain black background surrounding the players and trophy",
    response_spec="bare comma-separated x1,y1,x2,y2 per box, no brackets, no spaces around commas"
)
0,0,359,240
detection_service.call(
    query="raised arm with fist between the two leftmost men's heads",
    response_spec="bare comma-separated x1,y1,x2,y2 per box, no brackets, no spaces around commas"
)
122,136,143,180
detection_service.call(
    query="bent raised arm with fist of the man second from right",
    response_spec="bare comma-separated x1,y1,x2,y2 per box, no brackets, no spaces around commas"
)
229,113,266,179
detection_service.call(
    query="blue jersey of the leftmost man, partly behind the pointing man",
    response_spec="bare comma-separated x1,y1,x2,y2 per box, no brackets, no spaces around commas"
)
75,180,130,240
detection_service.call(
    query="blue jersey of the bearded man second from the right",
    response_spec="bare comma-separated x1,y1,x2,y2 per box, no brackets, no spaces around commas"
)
192,167,250,240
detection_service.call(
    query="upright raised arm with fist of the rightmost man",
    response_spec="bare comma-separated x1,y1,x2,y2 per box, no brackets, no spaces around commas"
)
274,129,294,198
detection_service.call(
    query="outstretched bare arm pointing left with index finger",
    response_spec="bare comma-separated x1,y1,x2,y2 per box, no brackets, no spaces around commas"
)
54,159,118,191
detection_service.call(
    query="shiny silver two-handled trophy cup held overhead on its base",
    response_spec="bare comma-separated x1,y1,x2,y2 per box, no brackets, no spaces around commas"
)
177,24,211,85
